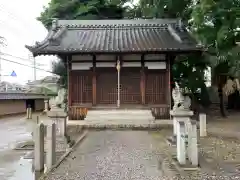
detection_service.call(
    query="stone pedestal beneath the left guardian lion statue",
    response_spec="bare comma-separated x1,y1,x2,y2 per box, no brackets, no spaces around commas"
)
47,107,67,137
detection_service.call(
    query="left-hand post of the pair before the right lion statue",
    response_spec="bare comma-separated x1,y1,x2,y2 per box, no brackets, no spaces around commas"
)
177,121,186,165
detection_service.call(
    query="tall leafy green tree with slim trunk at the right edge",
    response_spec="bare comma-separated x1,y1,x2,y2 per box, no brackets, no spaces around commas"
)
191,0,240,117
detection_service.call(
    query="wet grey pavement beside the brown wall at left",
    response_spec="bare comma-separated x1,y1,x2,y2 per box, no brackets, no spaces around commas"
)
0,115,33,180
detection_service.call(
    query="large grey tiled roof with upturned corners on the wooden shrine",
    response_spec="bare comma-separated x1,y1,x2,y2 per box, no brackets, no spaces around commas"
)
27,19,202,55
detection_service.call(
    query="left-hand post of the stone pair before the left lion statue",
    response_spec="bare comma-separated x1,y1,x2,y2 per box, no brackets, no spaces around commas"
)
33,123,44,171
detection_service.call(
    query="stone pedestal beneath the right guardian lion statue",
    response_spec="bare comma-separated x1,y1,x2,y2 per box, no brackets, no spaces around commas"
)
168,109,193,146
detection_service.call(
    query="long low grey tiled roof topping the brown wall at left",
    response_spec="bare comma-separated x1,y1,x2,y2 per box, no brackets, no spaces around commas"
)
0,92,48,100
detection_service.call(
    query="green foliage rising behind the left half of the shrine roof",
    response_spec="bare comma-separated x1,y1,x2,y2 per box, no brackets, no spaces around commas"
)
37,0,129,29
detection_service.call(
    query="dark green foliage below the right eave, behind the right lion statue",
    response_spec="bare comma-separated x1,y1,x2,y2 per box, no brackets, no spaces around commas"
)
172,54,210,107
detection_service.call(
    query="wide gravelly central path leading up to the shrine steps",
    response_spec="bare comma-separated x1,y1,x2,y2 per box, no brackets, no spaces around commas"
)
46,131,168,180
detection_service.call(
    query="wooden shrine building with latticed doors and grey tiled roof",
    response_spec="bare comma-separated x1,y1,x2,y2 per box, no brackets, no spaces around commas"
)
26,19,203,119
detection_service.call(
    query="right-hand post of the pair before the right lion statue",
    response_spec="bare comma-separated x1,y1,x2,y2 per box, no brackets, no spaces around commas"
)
188,121,198,166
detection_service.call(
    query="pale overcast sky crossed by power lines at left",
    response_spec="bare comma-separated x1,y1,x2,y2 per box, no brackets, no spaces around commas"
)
0,0,54,84
